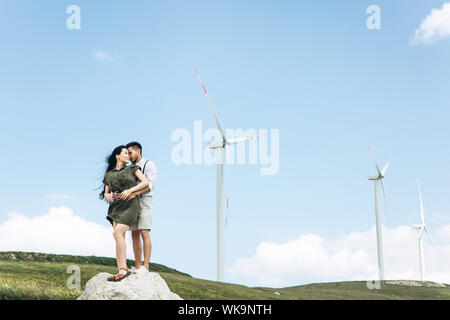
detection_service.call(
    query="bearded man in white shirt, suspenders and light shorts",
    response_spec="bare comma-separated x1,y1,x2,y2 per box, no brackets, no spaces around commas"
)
113,141,157,273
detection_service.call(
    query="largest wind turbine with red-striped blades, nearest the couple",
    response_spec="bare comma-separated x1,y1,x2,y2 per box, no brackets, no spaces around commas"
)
194,68,257,282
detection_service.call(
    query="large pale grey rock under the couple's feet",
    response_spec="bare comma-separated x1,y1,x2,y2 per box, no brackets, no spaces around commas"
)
78,272,183,300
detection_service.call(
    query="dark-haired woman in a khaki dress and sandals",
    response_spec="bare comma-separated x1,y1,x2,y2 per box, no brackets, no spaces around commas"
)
99,146,149,281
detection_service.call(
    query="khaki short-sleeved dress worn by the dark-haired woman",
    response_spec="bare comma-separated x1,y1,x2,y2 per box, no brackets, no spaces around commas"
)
103,164,141,227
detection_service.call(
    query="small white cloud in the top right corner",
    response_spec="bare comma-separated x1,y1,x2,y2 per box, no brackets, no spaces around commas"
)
411,2,450,45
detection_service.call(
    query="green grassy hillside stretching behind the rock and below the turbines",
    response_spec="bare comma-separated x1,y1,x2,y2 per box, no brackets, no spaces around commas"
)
0,252,450,300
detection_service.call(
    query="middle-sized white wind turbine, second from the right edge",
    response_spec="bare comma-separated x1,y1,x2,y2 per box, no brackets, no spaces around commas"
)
368,145,391,281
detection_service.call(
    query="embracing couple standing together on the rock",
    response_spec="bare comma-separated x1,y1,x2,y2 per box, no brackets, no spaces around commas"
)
99,142,157,281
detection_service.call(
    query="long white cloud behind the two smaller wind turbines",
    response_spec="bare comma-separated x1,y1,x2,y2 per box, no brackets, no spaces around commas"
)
226,225,450,287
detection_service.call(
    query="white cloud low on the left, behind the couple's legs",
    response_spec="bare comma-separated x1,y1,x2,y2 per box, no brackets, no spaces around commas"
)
0,206,133,258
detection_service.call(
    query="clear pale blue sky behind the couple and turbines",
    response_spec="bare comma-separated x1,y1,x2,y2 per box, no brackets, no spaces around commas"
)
0,0,450,284
